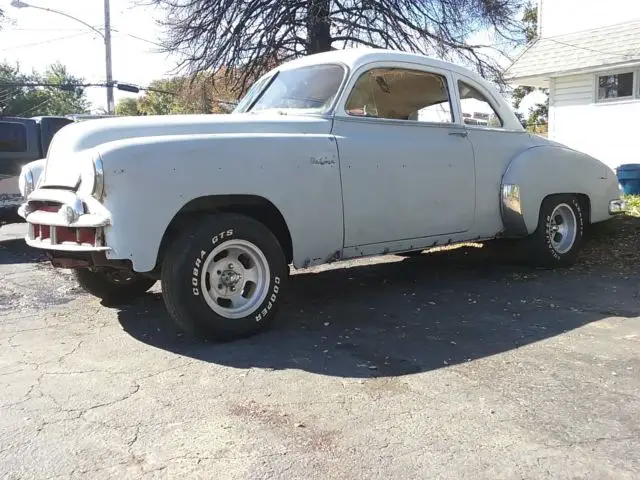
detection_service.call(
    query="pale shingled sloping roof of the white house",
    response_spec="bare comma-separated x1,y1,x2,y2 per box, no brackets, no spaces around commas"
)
505,20,640,85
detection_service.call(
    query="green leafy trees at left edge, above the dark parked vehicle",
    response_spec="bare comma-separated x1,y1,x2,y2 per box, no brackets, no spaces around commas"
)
0,63,89,117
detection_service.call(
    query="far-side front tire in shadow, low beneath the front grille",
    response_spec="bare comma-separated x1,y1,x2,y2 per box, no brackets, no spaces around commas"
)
74,268,156,304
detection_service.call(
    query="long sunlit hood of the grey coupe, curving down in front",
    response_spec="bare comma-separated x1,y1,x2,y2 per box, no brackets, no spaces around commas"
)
42,112,331,187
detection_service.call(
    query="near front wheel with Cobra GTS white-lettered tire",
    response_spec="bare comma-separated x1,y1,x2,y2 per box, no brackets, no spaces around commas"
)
162,214,288,341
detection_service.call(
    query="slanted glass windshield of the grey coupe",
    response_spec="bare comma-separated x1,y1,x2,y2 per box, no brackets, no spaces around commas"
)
238,65,345,113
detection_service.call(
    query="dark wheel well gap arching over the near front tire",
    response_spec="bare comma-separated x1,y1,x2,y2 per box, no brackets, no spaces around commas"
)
154,195,293,271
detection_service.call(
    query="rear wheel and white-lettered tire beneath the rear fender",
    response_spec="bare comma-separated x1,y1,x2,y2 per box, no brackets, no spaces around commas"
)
527,195,584,268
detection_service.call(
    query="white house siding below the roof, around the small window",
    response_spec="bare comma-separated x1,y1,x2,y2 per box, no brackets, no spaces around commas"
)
549,74,640,168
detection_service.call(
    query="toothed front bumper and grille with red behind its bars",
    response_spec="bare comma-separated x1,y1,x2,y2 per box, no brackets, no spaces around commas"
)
18,188,111,252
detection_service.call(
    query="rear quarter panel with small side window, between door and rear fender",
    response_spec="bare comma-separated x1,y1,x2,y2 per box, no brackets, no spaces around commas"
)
452,73,539,237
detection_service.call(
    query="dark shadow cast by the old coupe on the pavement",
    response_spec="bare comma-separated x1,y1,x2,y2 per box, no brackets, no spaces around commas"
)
119,249,640,378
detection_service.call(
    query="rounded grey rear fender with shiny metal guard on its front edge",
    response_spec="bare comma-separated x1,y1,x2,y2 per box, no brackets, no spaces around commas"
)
501,145,619,237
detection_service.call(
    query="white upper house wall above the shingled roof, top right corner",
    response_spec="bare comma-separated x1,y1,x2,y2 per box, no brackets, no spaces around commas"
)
538,0,640,37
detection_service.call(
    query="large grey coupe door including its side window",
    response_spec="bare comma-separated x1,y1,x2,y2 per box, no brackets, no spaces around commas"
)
333,63,475,247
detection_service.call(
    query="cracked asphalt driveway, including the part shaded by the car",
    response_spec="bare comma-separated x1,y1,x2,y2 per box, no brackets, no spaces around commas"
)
0,225,640,480
